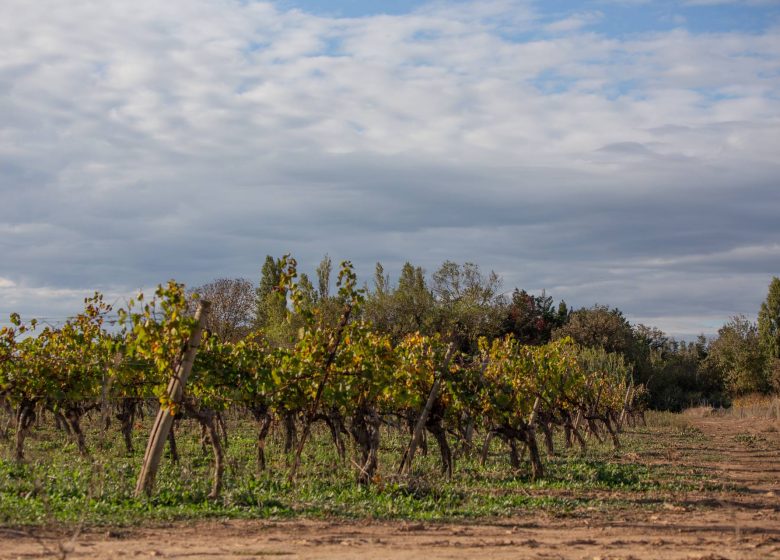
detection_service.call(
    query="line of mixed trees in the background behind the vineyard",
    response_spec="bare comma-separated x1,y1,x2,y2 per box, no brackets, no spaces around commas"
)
203,255,780,411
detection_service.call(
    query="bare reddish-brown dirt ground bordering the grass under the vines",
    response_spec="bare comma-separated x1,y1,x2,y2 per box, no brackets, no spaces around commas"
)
0,417,780,560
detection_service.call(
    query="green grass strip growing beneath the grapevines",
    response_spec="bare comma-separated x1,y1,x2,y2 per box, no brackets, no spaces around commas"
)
0,413,720,526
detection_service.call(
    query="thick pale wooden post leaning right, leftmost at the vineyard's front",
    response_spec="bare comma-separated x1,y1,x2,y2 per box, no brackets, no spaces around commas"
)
135,301,211,498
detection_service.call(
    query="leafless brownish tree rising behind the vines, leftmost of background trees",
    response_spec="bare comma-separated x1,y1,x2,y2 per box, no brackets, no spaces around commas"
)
192,278,255,342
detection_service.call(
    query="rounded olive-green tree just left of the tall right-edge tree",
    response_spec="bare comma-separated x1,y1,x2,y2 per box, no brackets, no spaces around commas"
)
707,315,769,396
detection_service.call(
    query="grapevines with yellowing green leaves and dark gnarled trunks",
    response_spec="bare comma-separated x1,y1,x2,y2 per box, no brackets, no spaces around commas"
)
0,258,643,497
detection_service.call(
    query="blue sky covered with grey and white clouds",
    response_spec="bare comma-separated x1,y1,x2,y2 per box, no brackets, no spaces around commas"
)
0,0,780,338
